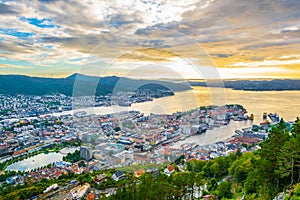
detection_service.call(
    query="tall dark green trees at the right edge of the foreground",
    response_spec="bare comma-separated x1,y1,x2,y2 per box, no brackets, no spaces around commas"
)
241,120,300,199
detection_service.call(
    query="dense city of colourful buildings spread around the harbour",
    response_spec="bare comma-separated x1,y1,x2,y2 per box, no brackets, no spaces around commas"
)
0,95,293,199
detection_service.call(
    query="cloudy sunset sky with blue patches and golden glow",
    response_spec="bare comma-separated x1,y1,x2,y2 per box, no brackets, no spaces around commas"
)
0,0,300,79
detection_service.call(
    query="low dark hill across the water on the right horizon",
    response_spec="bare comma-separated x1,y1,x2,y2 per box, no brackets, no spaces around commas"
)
190,79,300,91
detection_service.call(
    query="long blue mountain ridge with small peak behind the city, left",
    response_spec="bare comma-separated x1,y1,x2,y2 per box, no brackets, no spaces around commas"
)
0,74,191,96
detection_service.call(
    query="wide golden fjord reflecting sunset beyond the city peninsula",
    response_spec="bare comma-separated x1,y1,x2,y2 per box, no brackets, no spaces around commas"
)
69,87,300,123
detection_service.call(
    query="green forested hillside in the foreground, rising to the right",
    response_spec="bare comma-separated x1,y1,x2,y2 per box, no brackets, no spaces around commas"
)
109,119,300,200
